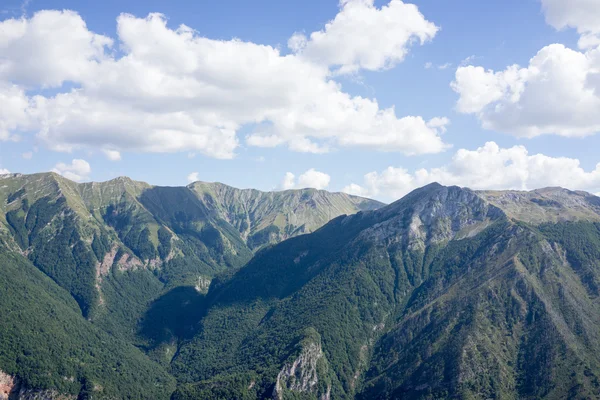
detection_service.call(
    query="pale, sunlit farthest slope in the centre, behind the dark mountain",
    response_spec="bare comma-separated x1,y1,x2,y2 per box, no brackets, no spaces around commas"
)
188,182,383,249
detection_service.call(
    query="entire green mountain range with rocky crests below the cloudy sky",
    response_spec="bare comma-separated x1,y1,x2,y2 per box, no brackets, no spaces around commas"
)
0,174,600,400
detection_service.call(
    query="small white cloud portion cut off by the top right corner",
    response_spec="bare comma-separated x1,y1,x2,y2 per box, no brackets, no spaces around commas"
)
542,0,600,49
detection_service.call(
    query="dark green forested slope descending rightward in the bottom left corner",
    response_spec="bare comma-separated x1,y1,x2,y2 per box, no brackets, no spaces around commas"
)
0,245,175,399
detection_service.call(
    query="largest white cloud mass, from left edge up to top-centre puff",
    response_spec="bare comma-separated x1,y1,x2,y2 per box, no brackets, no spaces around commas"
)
0,5,447,158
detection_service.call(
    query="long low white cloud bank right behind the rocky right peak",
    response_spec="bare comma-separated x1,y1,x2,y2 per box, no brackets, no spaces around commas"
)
343,142,600,200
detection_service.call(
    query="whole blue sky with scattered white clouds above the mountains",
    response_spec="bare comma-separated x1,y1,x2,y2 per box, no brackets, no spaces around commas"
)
0,0,600,201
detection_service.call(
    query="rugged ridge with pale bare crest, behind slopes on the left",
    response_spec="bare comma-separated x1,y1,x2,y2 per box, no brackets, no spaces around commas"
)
0,173,379,317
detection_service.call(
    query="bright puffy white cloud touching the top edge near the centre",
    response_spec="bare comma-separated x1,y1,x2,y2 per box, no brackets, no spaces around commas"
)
288,0,439,73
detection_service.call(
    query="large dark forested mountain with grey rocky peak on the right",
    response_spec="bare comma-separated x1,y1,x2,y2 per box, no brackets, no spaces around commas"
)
172,184,600,399
